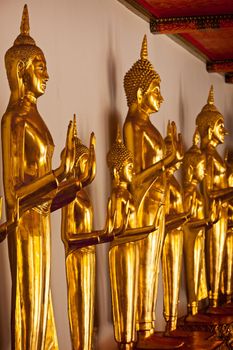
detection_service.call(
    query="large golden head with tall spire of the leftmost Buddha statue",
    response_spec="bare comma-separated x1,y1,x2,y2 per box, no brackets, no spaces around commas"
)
5,5,49,102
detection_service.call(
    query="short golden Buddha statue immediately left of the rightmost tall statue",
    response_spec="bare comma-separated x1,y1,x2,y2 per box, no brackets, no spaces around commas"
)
183,130,209,315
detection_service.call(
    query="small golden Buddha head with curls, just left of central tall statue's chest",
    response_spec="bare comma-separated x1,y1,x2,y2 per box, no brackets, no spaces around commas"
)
107,127,133,184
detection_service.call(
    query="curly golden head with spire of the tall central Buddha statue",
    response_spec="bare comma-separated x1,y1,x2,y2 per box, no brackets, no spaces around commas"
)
124,35,163,114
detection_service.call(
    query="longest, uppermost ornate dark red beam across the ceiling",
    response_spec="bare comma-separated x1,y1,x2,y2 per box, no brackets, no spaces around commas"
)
150,14,233,34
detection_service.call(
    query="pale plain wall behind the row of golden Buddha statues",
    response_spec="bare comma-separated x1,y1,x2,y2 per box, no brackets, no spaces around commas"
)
0,0,233,350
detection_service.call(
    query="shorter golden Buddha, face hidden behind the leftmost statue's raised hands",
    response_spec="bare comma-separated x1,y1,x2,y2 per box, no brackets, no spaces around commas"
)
61,120,96,350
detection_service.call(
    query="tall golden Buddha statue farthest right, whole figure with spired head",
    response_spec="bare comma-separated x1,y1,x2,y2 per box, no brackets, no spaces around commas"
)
196,87,233,311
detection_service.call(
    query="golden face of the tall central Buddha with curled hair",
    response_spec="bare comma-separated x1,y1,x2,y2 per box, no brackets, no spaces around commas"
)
141,80,163,113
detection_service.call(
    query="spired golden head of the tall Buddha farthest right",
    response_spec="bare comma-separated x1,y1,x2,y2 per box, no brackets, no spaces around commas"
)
196,86,227,147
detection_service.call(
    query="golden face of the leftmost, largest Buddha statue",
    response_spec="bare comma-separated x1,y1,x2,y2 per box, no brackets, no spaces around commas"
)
23,55,49,98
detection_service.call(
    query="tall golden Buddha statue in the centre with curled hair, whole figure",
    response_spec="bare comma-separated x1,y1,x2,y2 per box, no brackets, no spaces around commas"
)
124,36,179,341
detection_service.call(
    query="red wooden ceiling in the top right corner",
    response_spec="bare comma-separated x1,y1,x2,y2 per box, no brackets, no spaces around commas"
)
120,0,233,82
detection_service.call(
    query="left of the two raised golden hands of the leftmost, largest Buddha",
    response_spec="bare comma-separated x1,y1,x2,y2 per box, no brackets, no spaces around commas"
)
54,121,75,182
